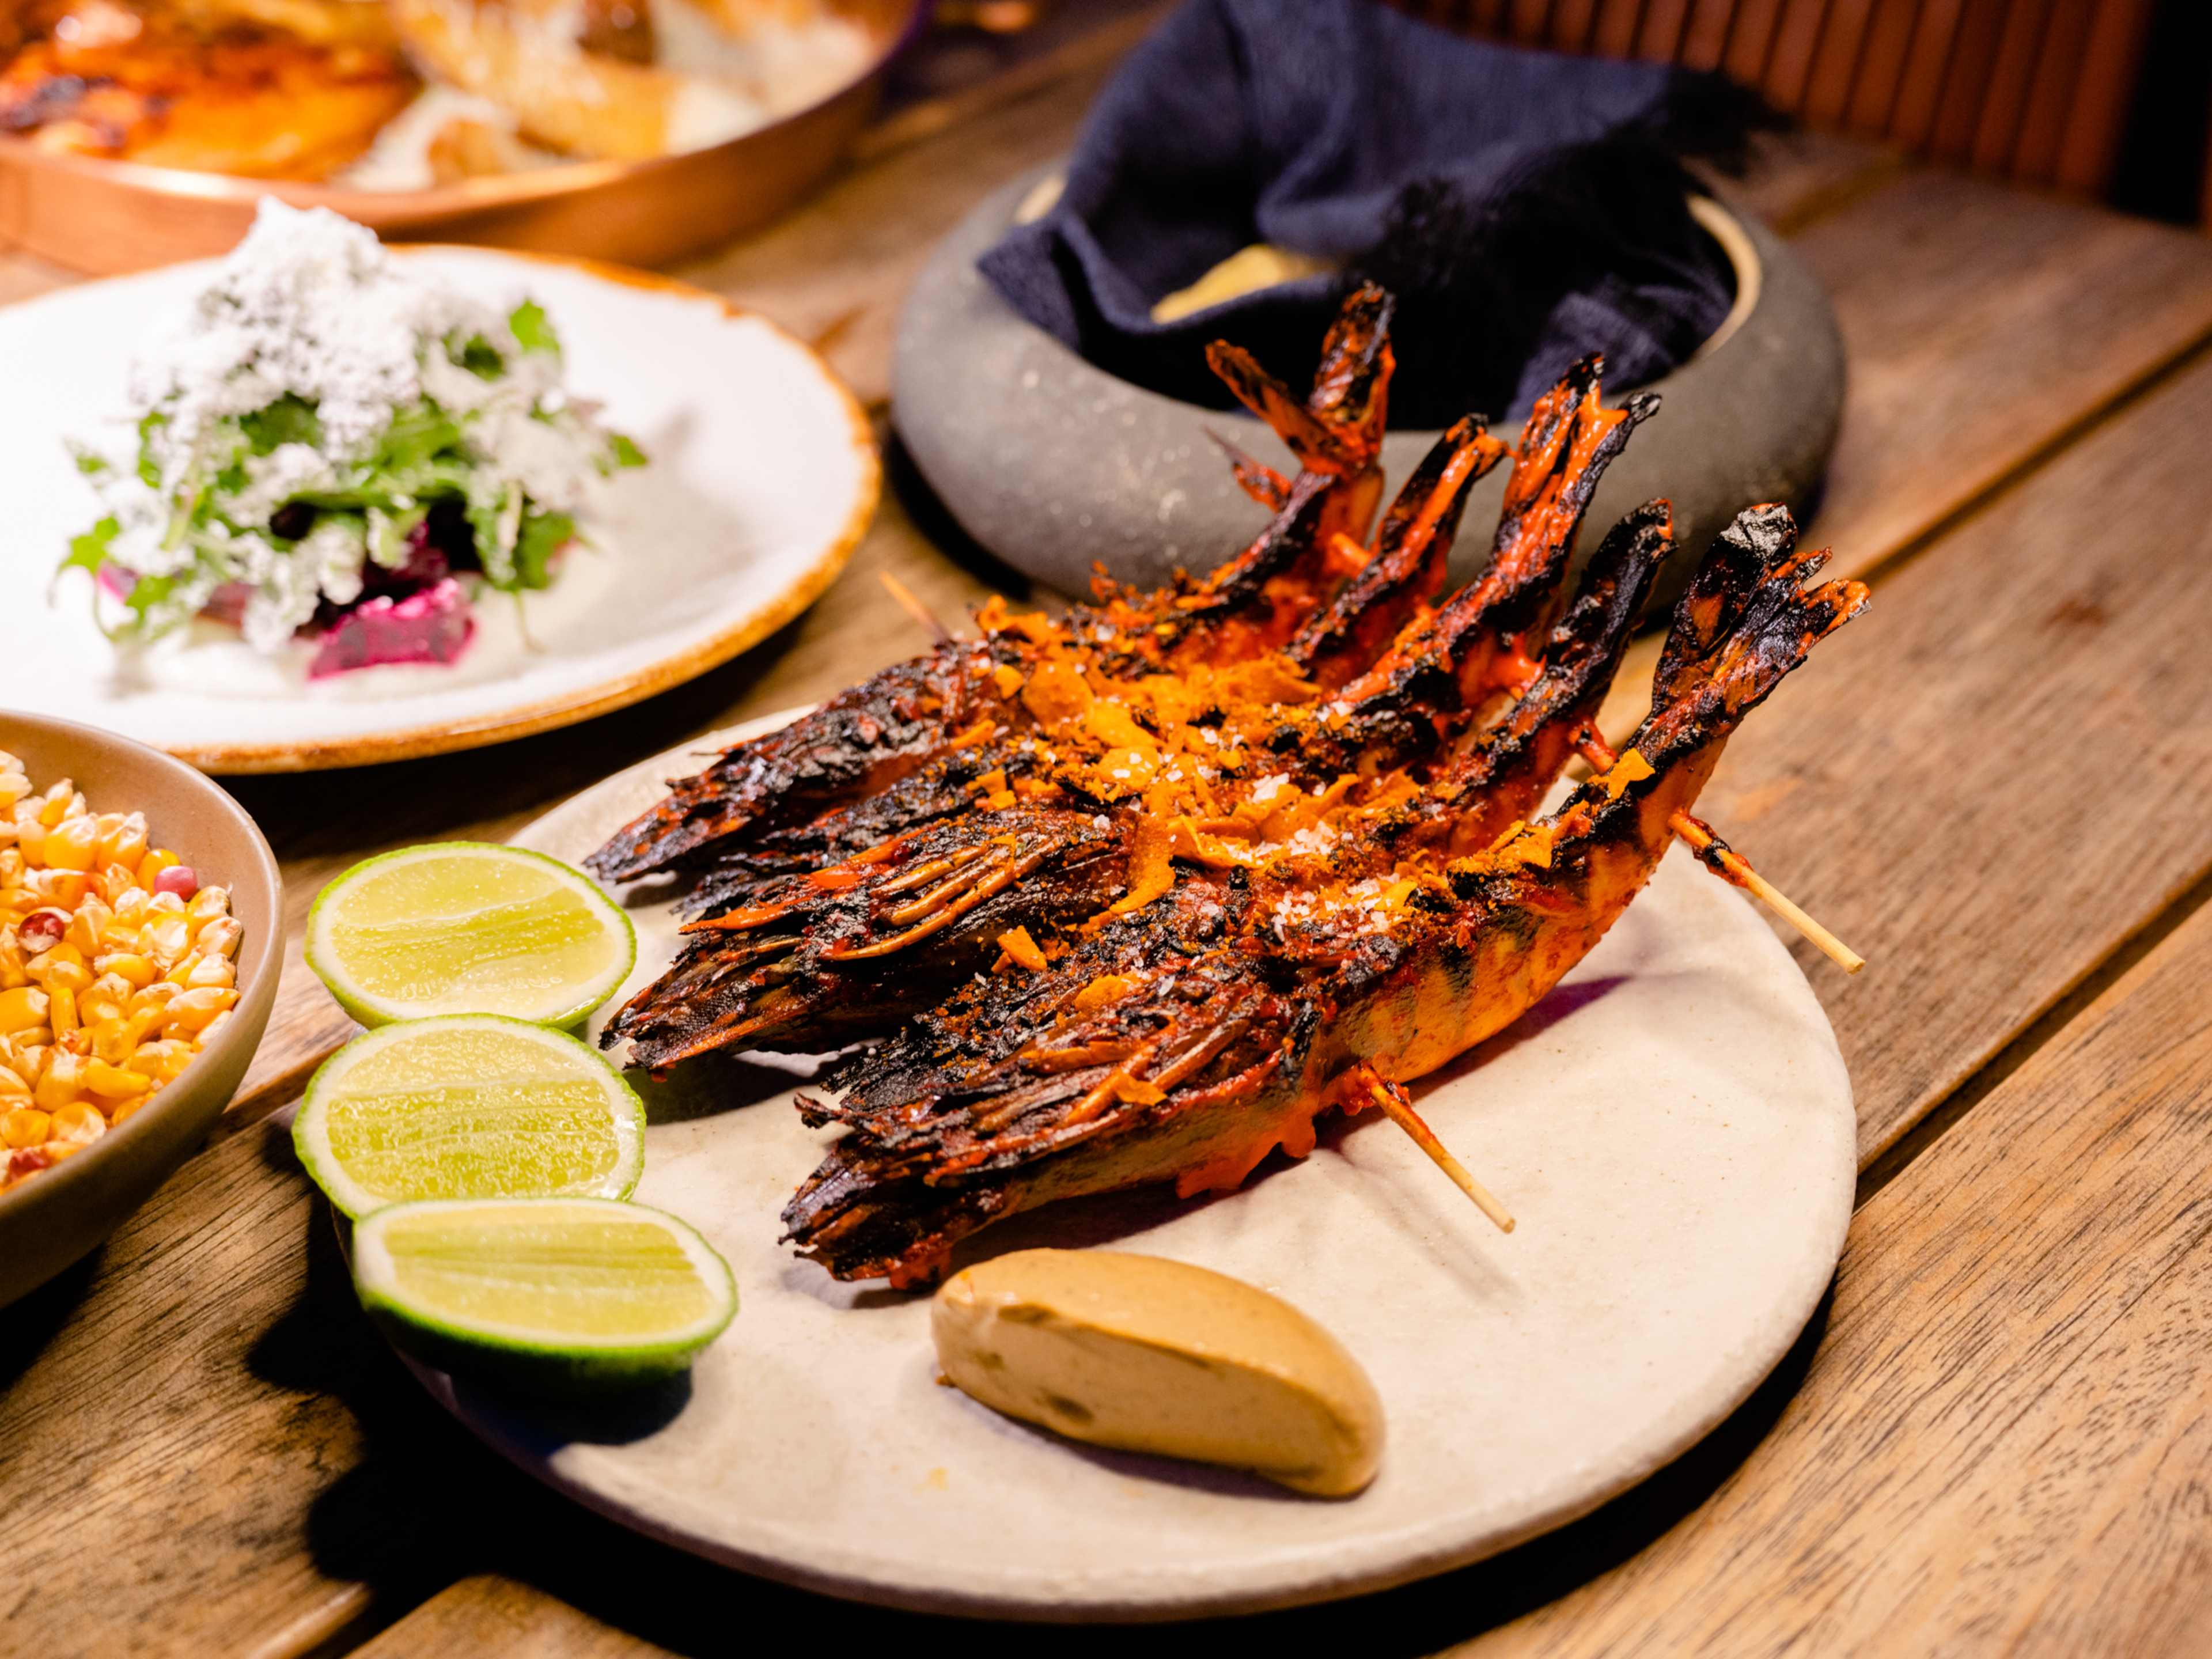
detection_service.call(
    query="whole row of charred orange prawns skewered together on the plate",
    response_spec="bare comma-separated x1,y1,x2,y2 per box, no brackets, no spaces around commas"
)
593,290,1865,1283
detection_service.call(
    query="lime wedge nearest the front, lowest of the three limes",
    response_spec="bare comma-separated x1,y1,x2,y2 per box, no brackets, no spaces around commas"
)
354,1199,737,1393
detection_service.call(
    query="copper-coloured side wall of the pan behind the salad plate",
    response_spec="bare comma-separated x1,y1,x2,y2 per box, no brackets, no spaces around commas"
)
0,0,929,276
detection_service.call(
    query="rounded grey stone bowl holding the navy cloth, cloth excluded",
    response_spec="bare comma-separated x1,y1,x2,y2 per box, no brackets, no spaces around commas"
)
893,161,1845,601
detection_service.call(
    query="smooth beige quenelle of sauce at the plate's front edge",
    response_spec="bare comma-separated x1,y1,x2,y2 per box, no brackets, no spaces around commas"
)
929,1250,1382,1498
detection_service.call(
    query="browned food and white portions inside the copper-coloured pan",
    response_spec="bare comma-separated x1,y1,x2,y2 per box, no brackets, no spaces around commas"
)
0,0,874,190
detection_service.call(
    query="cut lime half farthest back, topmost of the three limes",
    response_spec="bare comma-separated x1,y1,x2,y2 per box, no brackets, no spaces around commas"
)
308,840,637,1027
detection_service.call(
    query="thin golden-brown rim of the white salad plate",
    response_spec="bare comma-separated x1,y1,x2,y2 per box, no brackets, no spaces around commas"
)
5,256,882,777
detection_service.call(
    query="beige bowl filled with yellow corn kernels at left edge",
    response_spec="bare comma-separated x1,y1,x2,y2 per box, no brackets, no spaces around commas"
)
0,710,283,1307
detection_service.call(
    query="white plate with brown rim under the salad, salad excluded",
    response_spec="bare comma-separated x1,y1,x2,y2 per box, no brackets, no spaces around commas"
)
0,248,878,772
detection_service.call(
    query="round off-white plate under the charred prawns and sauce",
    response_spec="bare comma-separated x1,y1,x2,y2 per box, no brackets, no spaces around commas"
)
407,728,1856,1619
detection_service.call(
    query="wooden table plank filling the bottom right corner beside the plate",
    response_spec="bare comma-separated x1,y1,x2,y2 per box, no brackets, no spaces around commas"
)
1456,871,2212,1659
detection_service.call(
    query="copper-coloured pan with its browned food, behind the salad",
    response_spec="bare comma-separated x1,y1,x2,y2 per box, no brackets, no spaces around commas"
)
0,0,929,274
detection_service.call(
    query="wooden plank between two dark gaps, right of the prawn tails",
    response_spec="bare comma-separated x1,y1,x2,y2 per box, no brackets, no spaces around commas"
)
1608,345,2212,1157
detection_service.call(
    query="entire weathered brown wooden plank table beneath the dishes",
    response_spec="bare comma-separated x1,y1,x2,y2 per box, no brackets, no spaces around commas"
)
0,7,2212,1657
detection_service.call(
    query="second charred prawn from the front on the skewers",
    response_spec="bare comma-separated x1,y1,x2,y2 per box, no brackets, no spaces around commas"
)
601,486,1672,1069
